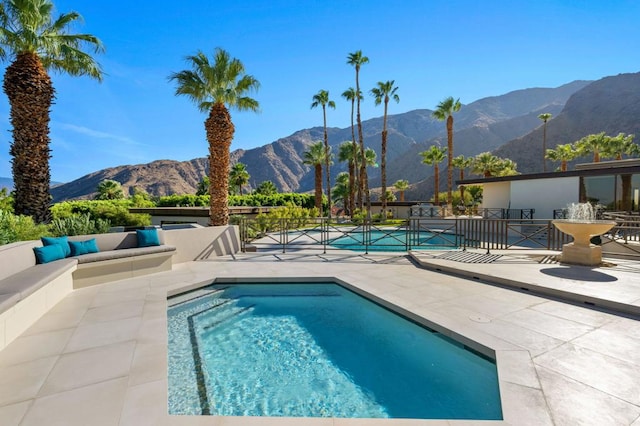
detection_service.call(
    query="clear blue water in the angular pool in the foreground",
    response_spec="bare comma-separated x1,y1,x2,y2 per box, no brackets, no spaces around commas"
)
168,283,502,419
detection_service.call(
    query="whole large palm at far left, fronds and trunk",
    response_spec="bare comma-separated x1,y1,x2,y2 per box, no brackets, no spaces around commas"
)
0,0,104,222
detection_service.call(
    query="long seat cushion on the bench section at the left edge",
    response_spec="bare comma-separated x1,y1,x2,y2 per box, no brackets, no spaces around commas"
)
0,259,77,303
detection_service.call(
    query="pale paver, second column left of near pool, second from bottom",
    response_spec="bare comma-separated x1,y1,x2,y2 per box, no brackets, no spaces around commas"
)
39,340,136,396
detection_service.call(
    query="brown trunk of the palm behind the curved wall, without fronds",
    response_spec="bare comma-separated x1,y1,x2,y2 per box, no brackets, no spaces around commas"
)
204,103,235,226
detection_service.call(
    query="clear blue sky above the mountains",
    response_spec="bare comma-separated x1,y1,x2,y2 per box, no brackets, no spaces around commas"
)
0,0,640,182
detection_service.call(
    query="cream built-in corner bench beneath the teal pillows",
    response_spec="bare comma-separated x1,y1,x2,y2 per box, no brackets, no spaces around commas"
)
0,230,176,350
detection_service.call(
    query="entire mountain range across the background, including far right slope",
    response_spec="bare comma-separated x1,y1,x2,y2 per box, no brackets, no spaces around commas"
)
5,73,640,201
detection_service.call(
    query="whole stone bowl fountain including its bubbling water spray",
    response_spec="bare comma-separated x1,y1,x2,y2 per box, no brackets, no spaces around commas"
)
553,203,616,266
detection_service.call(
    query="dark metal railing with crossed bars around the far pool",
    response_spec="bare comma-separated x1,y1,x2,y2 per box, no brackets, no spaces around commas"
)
238,216,640,255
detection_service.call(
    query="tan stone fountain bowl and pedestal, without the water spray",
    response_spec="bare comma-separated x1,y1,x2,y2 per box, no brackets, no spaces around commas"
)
552,219,616,266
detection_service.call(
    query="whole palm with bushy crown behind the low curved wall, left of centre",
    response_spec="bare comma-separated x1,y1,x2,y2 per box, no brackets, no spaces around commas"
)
169,48,260,226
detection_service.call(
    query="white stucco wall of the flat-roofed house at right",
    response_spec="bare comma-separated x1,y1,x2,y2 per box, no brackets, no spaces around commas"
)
510,177,580,219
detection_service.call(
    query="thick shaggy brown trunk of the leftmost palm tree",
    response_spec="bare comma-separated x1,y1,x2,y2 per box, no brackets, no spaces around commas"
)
3,53,55,223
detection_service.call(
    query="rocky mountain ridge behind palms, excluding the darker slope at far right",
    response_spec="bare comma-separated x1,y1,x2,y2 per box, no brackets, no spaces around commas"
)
51,81,590,201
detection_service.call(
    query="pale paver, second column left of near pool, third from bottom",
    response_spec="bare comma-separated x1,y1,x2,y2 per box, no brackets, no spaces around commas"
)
64,317,142,353
